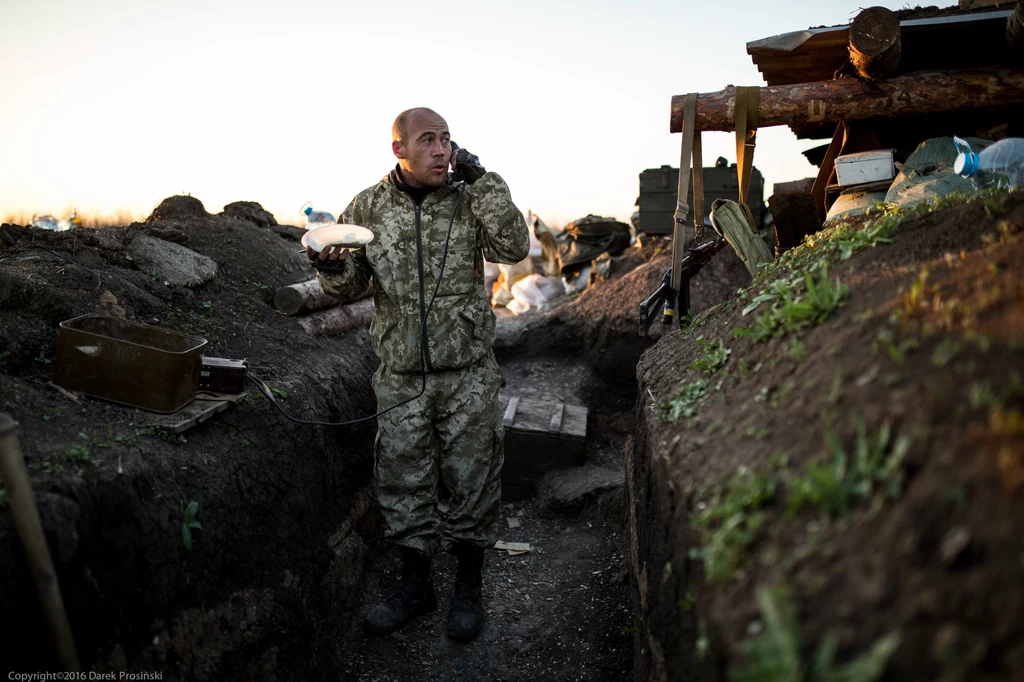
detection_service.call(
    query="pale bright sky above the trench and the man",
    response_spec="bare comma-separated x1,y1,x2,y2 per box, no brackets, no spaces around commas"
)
0,0,906,225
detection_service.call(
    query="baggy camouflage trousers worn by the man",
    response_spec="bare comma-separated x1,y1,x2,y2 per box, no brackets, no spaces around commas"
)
374,353,504,556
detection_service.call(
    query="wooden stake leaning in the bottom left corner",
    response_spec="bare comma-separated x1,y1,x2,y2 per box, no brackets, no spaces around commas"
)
0,413,81,672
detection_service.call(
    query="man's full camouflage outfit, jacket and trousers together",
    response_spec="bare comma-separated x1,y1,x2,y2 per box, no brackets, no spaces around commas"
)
318,168,529,555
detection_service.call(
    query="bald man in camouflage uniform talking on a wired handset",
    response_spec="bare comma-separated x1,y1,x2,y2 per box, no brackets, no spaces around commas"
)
307,109,529,640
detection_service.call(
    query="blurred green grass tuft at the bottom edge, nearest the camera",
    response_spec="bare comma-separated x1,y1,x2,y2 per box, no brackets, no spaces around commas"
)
729,588,900,682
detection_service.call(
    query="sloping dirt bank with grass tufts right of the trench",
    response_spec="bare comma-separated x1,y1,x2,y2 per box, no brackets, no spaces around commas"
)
627,191,1024,681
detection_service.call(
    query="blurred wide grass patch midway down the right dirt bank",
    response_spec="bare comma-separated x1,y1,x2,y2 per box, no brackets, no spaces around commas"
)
691,415,910,582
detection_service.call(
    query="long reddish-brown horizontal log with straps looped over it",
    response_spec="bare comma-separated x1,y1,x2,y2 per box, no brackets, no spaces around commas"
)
669,67,1024,132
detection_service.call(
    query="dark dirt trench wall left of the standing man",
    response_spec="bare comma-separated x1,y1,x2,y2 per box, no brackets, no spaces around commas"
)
0,206,381,680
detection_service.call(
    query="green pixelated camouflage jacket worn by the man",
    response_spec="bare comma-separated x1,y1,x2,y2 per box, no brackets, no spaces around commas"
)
318,172,529,373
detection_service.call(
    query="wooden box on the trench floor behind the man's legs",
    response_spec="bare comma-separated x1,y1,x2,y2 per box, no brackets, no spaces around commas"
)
500,395,587,502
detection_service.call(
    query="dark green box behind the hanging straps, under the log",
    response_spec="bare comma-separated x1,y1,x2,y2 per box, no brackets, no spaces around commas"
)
637,164,765,235
